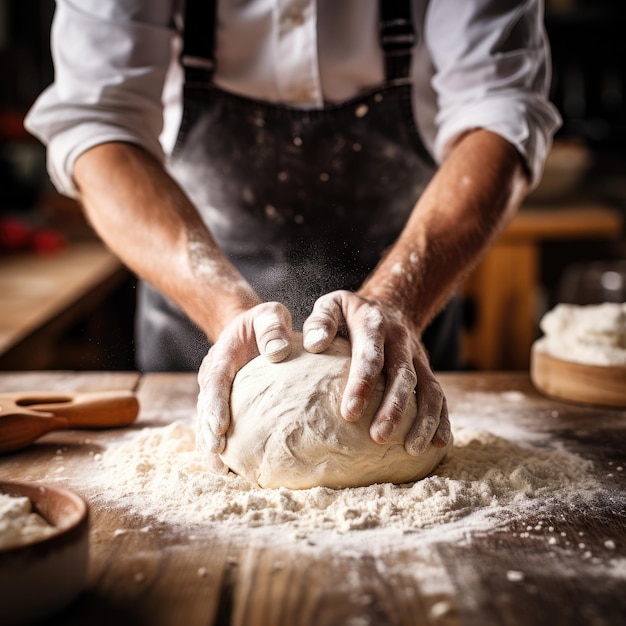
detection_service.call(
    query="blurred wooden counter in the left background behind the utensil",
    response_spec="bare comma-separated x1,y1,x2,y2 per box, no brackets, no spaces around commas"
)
0,242,134,371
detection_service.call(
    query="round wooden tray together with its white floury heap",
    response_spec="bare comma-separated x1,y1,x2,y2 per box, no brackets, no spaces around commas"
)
530,302,626,408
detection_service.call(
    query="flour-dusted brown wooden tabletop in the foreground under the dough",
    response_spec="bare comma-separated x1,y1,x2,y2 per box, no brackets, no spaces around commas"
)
0,372,626,626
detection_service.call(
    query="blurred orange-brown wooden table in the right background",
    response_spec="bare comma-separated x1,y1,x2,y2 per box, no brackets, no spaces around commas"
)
463,203,623,370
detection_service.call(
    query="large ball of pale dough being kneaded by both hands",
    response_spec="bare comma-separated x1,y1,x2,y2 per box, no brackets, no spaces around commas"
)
221,335,447,489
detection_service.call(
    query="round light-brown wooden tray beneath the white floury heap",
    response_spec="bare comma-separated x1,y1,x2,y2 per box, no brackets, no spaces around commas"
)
530,344,626,408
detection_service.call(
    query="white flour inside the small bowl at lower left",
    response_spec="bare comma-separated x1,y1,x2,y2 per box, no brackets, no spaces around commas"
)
0,493,55,550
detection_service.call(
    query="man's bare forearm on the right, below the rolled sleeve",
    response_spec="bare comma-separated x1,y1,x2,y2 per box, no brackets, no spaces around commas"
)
360,130,527,332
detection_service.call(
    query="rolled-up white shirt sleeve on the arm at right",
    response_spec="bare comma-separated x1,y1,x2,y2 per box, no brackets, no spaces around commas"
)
425,0,561,187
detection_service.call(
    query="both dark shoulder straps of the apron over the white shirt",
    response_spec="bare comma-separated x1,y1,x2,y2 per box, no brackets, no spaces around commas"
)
181,0,415,84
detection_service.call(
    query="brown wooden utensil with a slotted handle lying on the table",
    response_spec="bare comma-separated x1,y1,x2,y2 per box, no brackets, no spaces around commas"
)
0,391,139,454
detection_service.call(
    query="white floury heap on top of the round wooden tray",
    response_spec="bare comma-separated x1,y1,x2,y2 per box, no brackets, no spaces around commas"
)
537,302,626,366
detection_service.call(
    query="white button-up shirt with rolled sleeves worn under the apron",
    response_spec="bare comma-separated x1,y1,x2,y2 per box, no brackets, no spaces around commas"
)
26,0,560,196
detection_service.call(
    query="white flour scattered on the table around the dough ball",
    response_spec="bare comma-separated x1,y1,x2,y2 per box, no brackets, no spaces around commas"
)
75,422,595,535
